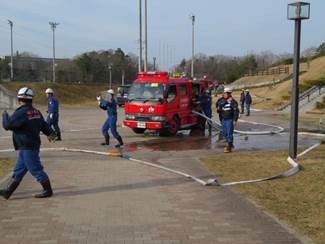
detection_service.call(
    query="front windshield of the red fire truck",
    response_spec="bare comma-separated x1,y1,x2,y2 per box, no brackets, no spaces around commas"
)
128,82,165,103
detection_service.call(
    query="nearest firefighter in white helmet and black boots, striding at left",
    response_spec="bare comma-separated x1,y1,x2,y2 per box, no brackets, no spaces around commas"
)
0,87,56,199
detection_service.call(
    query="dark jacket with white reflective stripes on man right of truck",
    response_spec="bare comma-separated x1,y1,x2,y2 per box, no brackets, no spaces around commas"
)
216,97,239,121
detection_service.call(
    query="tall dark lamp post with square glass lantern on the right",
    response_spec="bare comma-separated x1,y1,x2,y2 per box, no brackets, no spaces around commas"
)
288,1,310,158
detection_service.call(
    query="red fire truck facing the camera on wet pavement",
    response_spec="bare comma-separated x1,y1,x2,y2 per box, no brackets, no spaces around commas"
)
124,72,207,135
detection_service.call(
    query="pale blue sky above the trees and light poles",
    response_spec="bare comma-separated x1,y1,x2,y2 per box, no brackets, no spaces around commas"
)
0,0,325,68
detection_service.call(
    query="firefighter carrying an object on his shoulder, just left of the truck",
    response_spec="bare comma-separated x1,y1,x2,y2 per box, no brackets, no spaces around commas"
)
97,89,124,148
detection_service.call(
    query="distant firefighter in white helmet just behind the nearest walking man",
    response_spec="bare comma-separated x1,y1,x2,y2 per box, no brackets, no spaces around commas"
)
45,88,62,141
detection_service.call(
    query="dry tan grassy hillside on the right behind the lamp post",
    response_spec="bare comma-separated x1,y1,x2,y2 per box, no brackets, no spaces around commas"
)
235,57,325,110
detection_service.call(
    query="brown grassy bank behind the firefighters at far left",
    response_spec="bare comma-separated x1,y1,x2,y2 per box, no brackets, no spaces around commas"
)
1,82,108,107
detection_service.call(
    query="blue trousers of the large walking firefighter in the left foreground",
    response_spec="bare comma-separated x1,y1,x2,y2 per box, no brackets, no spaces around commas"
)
12,150,49,183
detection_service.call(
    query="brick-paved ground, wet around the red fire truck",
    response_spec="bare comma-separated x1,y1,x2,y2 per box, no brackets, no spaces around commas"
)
0,109,312,244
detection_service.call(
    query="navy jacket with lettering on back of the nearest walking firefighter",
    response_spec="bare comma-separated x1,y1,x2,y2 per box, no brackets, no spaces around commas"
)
2,103,54,150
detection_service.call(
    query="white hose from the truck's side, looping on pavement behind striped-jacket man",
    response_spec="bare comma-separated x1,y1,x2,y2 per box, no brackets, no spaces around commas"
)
192,110,284,135
